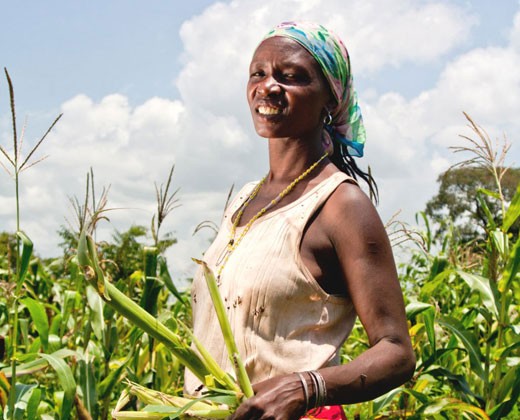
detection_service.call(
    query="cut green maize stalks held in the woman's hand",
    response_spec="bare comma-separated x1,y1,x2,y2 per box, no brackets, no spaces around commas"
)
77,229,253,419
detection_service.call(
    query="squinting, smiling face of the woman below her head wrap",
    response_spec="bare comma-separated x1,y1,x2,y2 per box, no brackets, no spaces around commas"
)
247,37,331,138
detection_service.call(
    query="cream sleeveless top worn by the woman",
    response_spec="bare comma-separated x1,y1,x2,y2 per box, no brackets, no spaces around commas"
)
185,172,356,394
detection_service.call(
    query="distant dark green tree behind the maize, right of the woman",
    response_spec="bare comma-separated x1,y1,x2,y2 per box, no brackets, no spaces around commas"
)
426,166,520,242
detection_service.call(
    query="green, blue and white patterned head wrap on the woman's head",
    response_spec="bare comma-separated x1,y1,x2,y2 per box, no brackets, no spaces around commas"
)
264,22,366,157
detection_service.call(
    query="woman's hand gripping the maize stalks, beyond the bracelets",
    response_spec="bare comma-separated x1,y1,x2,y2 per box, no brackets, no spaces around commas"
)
231,374,306,420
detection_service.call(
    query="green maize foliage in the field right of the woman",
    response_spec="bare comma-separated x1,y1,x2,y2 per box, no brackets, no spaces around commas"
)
345,113,520,419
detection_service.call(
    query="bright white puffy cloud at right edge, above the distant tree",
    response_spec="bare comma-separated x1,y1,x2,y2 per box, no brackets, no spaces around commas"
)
366,34,520,171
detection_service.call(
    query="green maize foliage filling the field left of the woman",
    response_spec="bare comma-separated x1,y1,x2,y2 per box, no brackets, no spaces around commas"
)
0,72,189,419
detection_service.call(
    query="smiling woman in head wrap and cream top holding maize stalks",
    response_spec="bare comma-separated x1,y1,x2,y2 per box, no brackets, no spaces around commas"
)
186,22,415,420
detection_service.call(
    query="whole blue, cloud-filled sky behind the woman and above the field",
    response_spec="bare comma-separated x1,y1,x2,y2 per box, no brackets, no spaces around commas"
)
0,0,520,279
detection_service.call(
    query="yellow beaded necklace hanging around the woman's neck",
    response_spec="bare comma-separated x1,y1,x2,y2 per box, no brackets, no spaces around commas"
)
217,153,328,279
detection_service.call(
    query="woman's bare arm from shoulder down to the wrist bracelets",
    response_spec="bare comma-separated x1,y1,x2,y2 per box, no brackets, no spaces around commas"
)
320,184,415,404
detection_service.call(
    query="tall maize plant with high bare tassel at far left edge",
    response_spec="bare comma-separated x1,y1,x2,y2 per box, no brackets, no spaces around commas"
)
0,68,75,420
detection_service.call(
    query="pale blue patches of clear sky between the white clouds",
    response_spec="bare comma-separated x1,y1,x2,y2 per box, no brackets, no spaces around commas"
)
4,0,518,108
